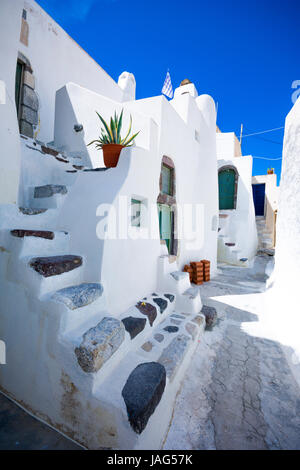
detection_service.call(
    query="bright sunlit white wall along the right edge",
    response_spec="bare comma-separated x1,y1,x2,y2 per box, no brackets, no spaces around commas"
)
270,99,300,356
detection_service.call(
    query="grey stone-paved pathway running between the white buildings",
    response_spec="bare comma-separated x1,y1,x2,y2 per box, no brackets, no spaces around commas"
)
164,256,300,450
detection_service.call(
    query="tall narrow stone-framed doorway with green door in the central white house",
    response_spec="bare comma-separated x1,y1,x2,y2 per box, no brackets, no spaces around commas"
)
157,156,178,255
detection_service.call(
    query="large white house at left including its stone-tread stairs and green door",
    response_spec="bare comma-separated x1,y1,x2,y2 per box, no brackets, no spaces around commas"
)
0,0,220,448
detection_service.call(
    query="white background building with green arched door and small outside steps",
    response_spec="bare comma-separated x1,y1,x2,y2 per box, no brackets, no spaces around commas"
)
216,128,257,266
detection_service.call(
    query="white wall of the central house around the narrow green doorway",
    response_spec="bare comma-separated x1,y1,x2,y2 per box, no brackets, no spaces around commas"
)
55,84,218,313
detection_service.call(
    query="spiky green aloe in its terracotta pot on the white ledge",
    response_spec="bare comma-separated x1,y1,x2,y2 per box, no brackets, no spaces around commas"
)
88,109,139,168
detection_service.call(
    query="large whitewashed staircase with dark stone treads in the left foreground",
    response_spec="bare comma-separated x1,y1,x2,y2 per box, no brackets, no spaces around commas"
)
0,138,209,449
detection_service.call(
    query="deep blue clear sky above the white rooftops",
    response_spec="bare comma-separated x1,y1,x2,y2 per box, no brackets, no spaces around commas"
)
38,0,300,181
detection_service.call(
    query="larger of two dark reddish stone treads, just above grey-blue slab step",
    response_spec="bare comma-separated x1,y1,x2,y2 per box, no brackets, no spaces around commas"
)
30,255,82,277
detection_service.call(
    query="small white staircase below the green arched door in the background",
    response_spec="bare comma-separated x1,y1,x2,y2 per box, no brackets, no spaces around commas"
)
218,212,249,267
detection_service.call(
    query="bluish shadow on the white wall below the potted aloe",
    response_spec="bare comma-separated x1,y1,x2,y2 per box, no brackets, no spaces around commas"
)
58,149,131,282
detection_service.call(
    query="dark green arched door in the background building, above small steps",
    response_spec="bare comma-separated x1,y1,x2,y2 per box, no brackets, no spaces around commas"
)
218,165,238,210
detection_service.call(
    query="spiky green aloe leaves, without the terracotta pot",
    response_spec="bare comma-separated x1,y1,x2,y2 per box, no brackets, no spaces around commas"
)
88,109,139,149
